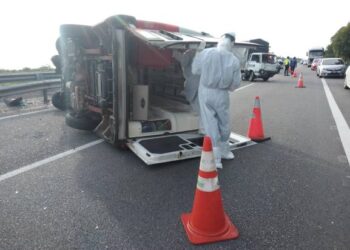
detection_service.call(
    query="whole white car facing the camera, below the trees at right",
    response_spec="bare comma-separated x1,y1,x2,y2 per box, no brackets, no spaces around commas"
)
316,58,346,78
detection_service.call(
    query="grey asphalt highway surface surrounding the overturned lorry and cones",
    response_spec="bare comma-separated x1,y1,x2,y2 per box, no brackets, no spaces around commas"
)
0,66,350,250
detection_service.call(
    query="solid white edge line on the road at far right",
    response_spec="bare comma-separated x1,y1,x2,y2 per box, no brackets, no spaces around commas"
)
321,79,350,168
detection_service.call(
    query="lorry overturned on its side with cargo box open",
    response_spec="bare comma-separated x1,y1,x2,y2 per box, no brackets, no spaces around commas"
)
52,15,255,165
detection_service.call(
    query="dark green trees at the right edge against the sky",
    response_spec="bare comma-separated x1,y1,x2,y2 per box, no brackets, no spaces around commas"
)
325,23,350,64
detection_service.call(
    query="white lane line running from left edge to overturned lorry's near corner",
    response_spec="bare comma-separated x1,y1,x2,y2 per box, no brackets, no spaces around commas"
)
0,139,104,182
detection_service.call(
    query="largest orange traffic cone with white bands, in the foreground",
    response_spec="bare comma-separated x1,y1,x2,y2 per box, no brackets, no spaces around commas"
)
181,136,239,244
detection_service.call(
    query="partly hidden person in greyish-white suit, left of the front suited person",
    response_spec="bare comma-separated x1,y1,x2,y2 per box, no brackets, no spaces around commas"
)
173,47,204,133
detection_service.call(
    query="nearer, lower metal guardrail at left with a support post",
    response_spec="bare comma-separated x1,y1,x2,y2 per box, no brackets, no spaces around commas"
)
0,79,61,103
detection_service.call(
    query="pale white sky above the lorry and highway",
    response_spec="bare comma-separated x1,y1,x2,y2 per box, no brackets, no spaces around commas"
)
0,0,350,69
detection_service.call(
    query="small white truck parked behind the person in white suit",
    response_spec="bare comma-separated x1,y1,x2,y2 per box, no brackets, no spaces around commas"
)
242,53,280,81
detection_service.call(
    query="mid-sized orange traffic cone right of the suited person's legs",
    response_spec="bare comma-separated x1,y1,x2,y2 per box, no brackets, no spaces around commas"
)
247,96,271,142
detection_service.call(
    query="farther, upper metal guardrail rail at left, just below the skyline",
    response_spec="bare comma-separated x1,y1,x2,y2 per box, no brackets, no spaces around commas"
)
0,72,61,83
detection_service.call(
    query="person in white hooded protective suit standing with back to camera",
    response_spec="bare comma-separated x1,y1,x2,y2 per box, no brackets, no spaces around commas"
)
192,33,241,168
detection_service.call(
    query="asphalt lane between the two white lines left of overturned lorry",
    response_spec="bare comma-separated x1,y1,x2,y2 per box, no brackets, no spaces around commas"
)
0,109,97,175
